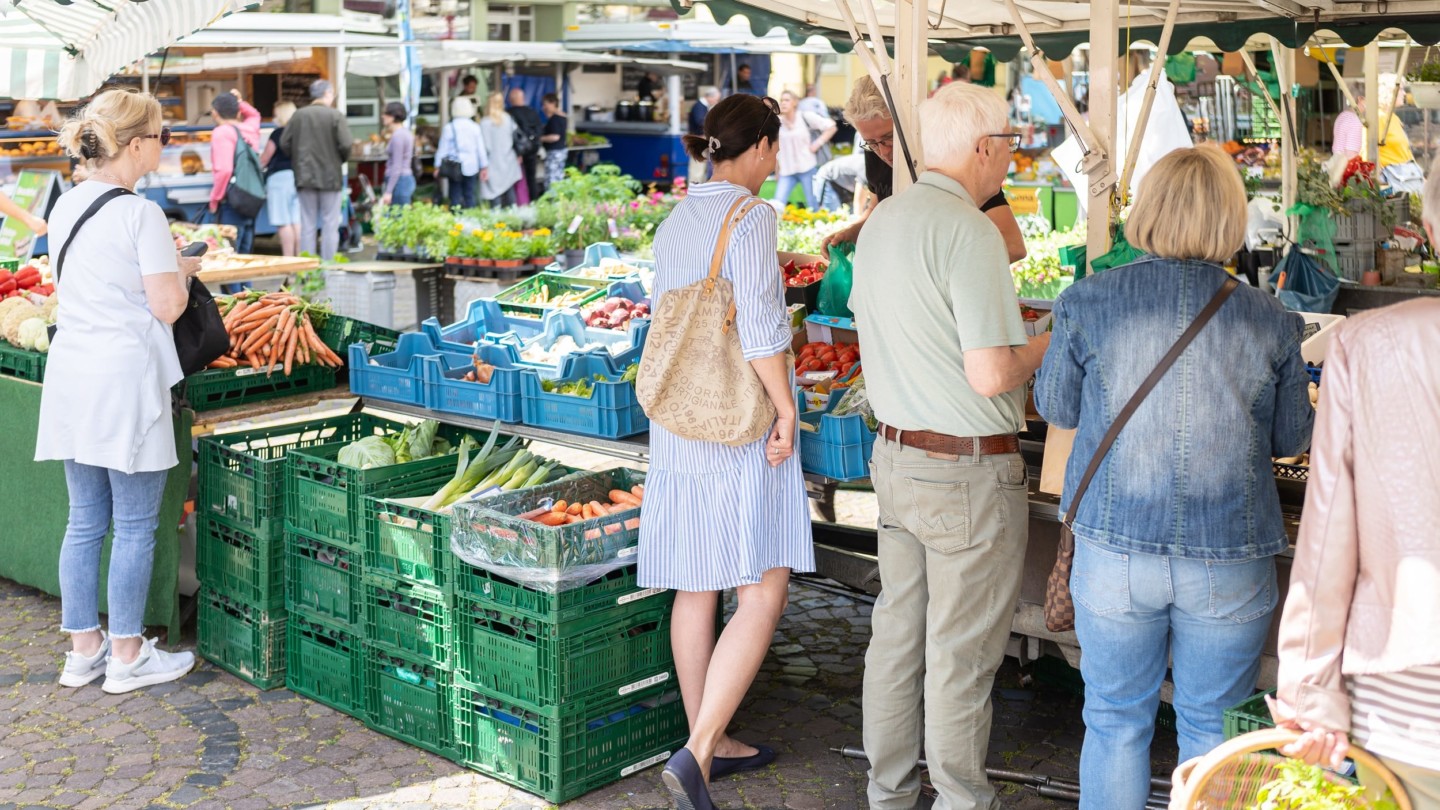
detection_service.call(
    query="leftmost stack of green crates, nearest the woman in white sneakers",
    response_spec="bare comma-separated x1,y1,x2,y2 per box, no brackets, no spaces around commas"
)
196,414,403,689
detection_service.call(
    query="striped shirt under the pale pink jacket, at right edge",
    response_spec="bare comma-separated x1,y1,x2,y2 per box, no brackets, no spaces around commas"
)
1348,664,1440,771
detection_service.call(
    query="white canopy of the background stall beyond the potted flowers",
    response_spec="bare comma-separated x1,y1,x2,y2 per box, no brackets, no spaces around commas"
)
346,39,706,78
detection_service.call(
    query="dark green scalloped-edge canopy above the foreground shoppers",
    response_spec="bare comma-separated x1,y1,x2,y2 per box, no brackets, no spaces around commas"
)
671,0,1440,61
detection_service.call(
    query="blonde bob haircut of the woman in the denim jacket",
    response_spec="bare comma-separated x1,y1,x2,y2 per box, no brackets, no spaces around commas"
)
1125,144,1247,264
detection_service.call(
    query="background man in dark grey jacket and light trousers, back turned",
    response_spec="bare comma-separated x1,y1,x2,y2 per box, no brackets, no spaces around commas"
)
279,79,351,261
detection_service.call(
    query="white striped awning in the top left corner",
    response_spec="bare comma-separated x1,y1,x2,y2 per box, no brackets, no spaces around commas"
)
0,0,255,101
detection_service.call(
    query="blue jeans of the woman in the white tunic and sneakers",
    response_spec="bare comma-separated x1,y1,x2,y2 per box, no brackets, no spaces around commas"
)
60,461,170,638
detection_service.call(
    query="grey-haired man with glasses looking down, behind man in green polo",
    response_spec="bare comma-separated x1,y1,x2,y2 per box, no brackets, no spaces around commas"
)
825,76,1025,262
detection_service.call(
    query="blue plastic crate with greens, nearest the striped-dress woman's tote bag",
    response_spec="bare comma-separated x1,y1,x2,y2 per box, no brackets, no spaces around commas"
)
520,355,649,438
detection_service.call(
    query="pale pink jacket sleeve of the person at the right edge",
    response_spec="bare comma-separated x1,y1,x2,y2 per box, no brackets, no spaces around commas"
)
1277,328,1359,732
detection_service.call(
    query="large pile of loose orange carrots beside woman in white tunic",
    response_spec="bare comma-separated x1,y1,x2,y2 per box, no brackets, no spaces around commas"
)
210,290,344,376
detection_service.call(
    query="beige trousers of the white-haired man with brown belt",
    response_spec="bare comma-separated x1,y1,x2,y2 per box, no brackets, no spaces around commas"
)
864,438,1030,810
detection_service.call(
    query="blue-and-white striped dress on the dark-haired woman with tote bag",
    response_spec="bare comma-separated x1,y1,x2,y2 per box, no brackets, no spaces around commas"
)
639,183,815,591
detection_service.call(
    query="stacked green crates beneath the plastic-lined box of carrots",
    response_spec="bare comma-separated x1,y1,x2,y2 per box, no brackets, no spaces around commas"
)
451,550,688,803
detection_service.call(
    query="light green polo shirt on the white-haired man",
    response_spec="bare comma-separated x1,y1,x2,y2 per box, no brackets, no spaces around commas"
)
850,172,1030,437
